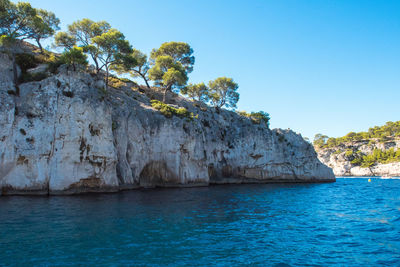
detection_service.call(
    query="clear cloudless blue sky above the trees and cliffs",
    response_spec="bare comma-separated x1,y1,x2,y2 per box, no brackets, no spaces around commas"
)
24,0,400,139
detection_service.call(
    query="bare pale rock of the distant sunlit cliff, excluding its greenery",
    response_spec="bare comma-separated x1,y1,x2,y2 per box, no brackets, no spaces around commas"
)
316,139,400,177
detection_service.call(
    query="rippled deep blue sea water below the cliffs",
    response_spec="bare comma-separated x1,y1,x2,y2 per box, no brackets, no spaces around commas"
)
0,178,400,266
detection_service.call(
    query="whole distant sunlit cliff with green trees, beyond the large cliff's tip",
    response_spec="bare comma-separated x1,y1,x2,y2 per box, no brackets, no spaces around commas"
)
314,121,400,176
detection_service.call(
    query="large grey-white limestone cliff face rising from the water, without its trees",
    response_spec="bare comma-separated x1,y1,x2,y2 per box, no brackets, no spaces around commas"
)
0,51,335,195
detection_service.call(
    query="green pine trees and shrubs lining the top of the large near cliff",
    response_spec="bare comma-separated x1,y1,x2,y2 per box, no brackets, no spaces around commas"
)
0,0,270,125
